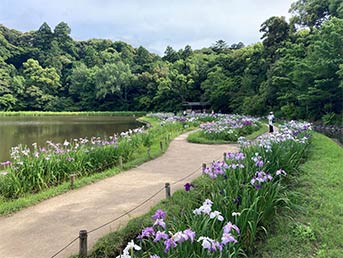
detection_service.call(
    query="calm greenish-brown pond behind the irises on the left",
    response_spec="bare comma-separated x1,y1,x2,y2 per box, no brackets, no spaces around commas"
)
0,115,142,162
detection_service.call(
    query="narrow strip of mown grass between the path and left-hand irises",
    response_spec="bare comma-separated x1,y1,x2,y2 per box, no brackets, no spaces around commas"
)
0,117,191,215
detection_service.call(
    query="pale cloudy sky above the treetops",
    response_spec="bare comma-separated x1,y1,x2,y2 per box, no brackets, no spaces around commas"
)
0,0,295,55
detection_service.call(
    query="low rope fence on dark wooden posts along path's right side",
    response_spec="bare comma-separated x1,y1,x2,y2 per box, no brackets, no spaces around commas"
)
51,153,226,258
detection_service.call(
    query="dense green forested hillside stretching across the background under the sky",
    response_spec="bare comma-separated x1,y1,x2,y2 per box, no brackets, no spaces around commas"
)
0,0,343,122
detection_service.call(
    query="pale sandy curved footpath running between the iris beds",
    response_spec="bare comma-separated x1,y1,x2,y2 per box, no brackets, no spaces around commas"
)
0,133,239,258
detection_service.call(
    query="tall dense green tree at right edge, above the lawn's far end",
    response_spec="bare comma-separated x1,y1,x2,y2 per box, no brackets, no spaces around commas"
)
306,18,343,118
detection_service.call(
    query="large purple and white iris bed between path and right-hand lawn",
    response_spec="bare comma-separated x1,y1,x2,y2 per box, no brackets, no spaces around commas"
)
111,121,311,258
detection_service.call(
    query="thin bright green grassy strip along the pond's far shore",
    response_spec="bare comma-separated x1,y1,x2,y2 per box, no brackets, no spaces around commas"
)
0,111,146,117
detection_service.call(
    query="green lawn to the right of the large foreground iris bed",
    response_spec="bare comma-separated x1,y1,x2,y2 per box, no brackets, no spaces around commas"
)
255,133,343,258
